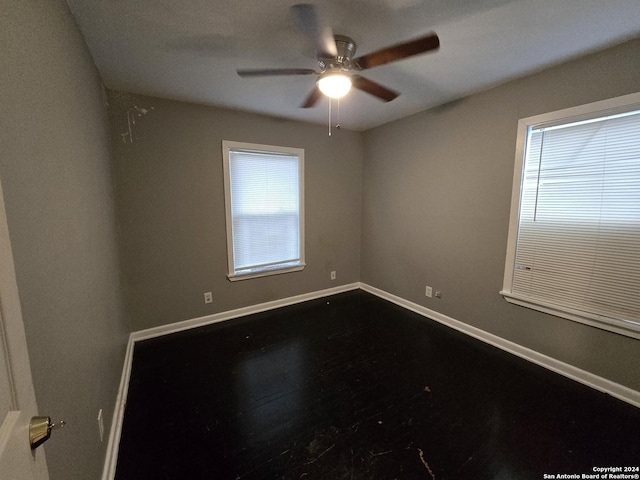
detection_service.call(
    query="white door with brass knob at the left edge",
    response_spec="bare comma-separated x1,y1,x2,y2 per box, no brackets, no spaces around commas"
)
0,174,49,480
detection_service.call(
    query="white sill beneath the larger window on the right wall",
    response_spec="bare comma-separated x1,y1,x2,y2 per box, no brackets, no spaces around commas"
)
500,290,640,339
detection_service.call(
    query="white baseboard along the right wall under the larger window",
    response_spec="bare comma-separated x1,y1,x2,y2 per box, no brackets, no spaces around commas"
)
360,283,640,407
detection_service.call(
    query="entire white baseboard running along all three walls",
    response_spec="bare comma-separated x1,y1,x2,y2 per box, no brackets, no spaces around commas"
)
102,283,640,480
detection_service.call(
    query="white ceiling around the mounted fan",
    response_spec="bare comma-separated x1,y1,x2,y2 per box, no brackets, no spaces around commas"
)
67,0,640,130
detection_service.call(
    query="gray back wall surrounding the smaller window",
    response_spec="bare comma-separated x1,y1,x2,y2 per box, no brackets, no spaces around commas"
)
109,92,362,330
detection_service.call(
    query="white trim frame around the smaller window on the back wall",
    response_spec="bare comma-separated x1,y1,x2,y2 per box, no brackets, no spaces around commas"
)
222,140,306,282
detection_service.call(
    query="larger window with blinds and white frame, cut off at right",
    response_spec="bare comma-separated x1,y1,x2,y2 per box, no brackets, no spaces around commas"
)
500,94,640,338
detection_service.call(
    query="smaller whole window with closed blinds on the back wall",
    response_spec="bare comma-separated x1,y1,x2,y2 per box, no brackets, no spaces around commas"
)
222,141,305,281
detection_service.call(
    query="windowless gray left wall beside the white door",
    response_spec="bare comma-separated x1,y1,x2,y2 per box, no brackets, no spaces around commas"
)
0,0,128,480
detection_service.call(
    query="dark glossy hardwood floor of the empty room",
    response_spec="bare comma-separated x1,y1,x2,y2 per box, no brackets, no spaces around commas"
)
116,291,640,480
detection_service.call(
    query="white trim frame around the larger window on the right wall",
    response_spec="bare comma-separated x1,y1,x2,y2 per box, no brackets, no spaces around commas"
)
500,89,640,339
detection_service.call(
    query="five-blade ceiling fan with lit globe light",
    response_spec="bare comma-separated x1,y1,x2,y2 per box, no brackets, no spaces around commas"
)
237,3,440,108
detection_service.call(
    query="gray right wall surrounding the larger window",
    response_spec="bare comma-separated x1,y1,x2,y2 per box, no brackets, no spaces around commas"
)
361,36,640,390
